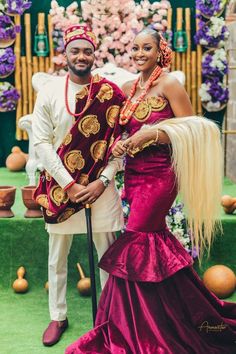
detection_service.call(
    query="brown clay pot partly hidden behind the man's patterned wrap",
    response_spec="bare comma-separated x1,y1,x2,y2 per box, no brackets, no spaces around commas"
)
21,186,43,218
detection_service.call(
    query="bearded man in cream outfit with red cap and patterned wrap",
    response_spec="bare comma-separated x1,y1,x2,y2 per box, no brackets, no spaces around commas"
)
32,25,124,346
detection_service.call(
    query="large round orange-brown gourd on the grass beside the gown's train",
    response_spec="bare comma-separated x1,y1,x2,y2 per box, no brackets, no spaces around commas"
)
203,264,236,299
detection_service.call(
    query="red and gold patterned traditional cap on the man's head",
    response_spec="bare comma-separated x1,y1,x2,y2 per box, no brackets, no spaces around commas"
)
64,25,97,49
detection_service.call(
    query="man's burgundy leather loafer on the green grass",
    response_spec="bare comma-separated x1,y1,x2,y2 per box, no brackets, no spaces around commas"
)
43,319,68,347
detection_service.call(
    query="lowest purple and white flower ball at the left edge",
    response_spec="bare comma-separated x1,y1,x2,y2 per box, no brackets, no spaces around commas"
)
0,81,20,112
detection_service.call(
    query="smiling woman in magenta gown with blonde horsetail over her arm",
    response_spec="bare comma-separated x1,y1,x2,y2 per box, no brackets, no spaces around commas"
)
66,29,236,354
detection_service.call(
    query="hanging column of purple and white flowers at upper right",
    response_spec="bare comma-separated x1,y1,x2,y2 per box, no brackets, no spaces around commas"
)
195,0,229,112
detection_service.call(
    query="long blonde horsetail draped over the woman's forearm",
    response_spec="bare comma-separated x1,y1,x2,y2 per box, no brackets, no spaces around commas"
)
152,116,223,259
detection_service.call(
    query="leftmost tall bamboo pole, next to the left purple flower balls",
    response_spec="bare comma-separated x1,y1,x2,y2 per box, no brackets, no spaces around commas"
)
14,15,23,140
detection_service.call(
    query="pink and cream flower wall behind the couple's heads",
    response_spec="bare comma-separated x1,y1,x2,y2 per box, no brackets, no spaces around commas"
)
50,0,171,72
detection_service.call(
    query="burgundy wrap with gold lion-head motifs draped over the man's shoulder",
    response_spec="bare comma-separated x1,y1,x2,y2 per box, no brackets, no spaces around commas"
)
34,75,124,224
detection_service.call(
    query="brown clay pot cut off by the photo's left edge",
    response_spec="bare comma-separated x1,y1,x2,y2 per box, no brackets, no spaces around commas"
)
0,186,16,218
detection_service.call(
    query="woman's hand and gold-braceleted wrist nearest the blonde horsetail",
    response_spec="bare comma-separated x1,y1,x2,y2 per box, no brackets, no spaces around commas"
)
123,129,157,156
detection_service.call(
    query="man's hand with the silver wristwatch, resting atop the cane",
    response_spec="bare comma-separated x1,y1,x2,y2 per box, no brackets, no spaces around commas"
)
75,179,106,204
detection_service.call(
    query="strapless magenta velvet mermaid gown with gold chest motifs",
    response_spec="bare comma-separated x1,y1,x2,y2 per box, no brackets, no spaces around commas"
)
66,98,236,354
